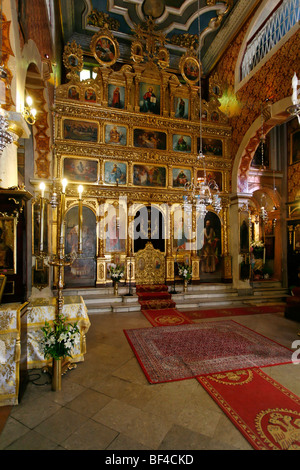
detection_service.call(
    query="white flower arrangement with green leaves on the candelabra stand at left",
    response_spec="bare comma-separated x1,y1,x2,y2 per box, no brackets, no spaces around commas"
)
41,316,80,359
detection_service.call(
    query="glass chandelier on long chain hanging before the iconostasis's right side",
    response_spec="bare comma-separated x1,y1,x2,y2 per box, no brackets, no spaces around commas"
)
183,0,222,218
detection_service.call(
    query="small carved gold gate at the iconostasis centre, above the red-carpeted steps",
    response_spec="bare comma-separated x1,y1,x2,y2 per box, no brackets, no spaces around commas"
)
135,242,165,284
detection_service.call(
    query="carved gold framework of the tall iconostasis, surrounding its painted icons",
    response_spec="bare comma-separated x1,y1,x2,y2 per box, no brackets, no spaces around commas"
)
55,37,232,285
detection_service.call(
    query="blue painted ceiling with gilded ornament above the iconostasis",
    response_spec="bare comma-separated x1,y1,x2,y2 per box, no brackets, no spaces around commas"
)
60,0,259,73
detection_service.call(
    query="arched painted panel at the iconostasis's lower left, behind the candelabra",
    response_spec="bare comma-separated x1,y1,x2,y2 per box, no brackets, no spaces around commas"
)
64,206,96,287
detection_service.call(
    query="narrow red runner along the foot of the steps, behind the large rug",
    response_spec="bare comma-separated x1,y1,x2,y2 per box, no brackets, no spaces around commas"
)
181,305,284,320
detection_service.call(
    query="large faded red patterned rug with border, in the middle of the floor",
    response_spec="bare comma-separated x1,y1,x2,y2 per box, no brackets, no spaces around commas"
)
124,320,292,383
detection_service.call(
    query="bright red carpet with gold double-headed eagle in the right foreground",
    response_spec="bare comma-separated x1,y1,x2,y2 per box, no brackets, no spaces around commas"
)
198,369,300,450
